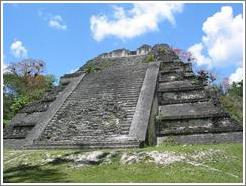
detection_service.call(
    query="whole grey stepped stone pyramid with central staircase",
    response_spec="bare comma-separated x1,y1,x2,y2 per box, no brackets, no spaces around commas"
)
3,44,243,149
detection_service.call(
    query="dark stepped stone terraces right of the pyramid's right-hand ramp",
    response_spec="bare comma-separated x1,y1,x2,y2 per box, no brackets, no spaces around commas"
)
156,61,242,143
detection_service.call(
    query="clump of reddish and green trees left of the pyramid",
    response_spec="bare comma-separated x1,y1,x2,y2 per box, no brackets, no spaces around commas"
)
3,59,55,126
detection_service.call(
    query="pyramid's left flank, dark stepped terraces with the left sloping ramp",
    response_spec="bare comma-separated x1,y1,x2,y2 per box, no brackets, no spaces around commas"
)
4,72,86,148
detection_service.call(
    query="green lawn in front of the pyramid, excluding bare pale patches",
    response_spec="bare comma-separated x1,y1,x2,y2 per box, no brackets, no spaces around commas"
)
4,143,243,183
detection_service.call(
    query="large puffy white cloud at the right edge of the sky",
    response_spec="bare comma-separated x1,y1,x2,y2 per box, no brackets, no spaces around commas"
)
188,6,244,67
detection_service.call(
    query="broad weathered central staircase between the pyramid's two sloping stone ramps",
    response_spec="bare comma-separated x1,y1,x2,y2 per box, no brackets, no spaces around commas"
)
34,62,148,148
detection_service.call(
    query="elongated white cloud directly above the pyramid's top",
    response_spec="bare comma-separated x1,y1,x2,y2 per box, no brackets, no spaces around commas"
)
90,2,183,41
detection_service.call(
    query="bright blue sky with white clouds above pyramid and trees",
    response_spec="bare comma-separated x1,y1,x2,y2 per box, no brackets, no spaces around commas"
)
3,2,244,81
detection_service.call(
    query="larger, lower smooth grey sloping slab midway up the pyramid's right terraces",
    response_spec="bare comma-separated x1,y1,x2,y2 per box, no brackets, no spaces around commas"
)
159,102,224,120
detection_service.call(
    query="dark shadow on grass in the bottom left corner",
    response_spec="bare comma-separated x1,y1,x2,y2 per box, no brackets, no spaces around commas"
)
3,165,71,183
